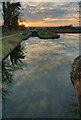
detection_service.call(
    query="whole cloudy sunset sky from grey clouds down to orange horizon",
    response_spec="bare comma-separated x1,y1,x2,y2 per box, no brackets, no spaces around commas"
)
21,2,79,26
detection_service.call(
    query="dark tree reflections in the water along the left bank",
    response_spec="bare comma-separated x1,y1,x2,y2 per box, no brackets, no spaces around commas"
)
2,44,25,103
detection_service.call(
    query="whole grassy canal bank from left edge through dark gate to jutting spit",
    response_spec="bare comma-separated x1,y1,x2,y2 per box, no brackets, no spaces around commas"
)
2,30,60,60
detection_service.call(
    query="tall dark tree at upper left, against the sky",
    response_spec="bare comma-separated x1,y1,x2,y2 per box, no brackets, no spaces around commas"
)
3,2,21,29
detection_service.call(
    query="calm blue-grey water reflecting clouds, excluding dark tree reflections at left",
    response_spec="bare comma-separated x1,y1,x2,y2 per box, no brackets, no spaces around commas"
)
3,34,79,118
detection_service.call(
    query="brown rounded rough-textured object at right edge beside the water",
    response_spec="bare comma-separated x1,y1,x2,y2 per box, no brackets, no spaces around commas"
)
71,55,81,117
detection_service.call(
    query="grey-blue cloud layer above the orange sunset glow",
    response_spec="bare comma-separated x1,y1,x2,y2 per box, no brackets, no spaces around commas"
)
19,2,79,23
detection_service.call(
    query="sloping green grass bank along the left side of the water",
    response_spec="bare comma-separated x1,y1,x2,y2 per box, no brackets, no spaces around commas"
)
2,32,29,59
